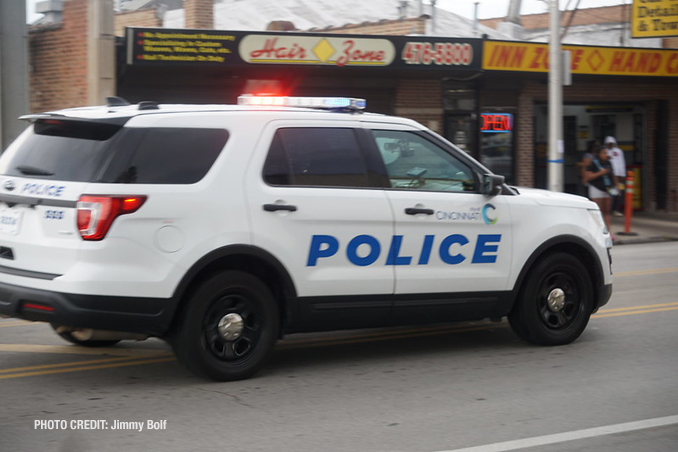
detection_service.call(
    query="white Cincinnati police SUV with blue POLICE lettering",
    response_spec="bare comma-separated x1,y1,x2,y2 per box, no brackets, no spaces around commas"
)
0,96,612,380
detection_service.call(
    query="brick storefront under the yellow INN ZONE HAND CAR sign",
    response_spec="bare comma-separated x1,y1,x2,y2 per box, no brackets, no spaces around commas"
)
481,41,678,211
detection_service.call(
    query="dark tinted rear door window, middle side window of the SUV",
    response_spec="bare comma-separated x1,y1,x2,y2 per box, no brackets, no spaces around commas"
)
264,128,369,187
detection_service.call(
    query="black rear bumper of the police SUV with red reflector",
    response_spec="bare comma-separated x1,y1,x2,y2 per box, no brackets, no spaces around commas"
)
0,283,177,336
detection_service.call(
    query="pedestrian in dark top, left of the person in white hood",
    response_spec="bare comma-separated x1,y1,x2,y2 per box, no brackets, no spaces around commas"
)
584,145,618,239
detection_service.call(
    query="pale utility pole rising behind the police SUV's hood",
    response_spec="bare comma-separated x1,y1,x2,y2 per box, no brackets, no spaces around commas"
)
548,0,565,192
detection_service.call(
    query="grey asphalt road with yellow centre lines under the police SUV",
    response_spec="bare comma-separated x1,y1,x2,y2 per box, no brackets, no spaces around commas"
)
0,242,678,452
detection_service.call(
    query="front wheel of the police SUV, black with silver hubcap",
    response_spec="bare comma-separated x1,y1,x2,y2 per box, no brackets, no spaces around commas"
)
508,253,594,345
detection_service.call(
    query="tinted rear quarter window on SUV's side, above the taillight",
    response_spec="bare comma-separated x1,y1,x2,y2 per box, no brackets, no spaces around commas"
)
101,128,228,184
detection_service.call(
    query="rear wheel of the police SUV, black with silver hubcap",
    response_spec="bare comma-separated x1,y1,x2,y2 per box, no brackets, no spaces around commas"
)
171,271,279,381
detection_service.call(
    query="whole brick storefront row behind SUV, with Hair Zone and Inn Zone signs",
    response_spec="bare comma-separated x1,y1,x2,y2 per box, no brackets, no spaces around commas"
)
25,0,678,211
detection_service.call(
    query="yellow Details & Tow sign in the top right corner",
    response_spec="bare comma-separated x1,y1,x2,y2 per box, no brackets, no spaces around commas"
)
631,0,678,38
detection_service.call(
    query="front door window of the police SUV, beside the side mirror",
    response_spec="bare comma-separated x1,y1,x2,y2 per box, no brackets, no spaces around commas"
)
372,130,478,192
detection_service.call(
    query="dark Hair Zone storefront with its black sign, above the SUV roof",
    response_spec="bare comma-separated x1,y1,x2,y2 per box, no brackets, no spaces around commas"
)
117,28,483,161
